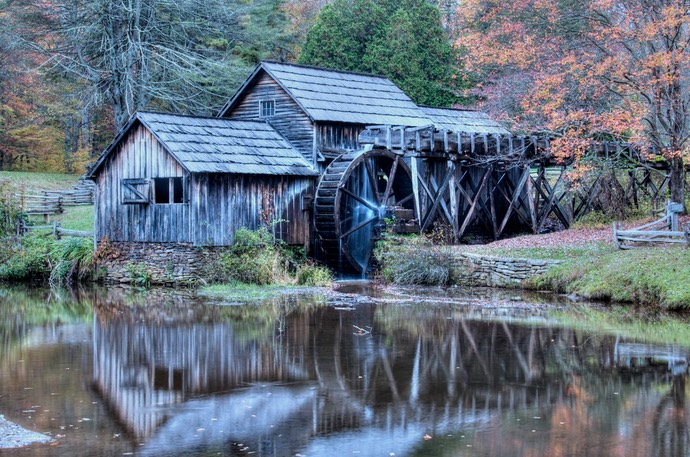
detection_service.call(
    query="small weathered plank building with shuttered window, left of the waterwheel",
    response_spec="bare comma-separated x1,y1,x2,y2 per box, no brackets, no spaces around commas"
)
89,112,318,278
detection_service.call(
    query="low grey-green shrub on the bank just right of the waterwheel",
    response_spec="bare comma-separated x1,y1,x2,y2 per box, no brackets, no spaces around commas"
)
374,236,452,285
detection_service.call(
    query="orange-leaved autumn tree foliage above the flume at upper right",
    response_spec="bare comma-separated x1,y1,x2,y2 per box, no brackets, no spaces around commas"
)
457,0,690,201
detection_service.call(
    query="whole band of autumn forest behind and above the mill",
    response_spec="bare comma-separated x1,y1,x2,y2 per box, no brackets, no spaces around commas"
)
0,0,690,206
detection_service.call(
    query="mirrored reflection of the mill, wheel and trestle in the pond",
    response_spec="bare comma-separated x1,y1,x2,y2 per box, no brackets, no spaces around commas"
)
94,298,687,455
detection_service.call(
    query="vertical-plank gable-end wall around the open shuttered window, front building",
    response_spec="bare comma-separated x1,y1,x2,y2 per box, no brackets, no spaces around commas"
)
94,121,191,242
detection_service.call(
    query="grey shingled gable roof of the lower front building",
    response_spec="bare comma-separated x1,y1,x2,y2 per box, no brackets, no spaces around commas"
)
89,112,318,177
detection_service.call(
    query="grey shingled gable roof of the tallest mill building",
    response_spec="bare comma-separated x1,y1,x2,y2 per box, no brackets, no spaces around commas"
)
219,62,431,127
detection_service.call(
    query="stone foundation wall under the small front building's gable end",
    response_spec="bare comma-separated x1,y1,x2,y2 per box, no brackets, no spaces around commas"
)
98,241,219,284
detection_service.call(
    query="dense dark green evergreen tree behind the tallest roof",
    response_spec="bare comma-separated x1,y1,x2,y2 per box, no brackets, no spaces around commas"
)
299,0,461,106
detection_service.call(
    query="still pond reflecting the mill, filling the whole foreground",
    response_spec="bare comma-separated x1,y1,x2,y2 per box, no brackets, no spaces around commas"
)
0,285,690,457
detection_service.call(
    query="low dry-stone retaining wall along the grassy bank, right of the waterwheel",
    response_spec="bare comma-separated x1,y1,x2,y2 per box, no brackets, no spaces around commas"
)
452,252,561,287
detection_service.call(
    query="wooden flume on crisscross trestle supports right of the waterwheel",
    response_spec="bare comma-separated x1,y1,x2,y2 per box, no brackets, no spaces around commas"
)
359,125,680,242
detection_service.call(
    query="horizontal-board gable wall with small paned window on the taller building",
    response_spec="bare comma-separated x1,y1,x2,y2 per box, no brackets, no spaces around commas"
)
226,72,315,164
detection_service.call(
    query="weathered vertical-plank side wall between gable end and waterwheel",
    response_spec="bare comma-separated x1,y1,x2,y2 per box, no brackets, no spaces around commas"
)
190,174,314,246
